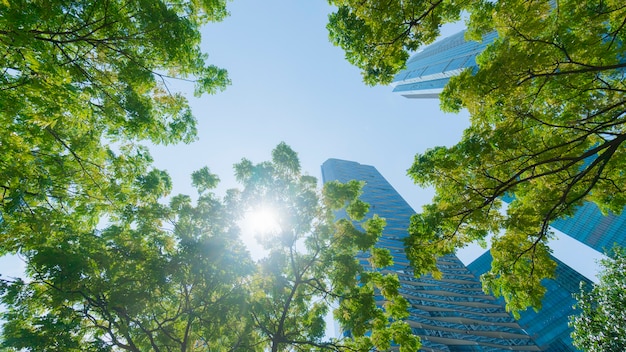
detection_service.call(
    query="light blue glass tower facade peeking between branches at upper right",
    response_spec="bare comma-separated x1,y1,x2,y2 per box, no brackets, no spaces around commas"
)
392,31,496,98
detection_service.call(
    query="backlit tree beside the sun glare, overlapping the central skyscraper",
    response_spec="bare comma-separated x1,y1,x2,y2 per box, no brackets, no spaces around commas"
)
235,143,419,351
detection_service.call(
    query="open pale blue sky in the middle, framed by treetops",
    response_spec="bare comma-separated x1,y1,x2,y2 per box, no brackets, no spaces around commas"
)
147,0,467,208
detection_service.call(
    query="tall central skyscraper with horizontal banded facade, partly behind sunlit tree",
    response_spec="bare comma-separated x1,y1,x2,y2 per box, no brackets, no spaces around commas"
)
322,159,539,352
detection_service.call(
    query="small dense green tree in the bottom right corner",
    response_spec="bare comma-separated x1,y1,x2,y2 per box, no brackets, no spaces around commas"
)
570,247,626,352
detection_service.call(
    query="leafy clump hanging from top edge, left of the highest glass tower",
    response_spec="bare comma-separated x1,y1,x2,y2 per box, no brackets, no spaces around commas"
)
327,0,474,85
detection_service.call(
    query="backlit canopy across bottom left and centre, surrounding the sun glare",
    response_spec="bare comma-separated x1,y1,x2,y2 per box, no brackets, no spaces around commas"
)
0,143,419,351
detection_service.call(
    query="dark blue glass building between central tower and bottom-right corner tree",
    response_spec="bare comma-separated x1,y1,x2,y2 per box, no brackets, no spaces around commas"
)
467,251,592,352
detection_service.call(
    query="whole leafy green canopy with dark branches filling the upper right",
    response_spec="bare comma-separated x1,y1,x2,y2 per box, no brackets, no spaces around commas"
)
329,0,626,311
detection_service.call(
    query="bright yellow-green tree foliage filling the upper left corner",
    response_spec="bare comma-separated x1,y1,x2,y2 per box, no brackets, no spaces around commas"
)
0,0,228,255
